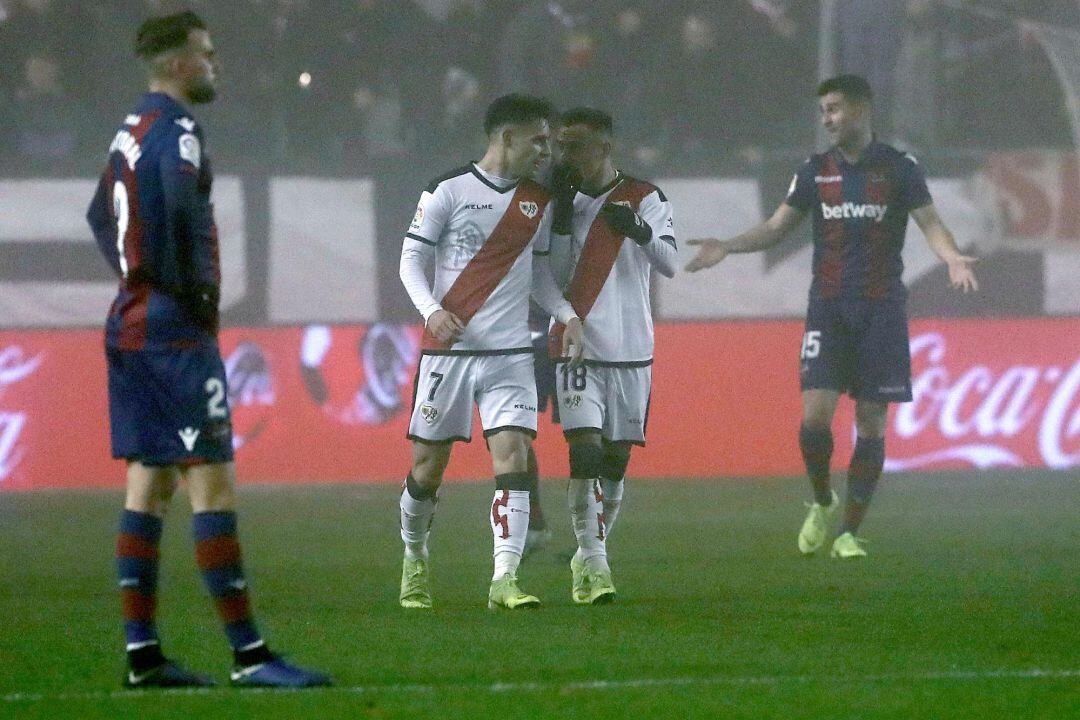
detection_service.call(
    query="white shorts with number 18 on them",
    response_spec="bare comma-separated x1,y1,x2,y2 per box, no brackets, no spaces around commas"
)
555,362,652,445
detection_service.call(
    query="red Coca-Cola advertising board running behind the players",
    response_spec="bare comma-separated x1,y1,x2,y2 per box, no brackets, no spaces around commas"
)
0,318,1080,490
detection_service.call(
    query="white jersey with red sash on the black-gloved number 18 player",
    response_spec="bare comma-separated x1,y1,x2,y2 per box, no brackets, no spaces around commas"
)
551,174,677,364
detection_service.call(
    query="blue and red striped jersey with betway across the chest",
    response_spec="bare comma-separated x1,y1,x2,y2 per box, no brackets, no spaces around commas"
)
785,141,933,299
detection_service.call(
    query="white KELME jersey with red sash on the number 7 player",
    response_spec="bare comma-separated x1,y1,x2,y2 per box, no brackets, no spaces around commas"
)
402,164,550,354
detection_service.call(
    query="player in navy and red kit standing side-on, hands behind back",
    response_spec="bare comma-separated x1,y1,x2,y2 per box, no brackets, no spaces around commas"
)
86,13,329,688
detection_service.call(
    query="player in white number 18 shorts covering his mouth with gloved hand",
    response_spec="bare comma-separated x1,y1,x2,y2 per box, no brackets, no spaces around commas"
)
551,108,677,604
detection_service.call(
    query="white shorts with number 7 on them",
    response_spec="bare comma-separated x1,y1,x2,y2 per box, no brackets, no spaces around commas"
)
408,350,537,443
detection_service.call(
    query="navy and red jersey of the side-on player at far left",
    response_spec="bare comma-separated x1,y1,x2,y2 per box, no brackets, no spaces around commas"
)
86,93,221,350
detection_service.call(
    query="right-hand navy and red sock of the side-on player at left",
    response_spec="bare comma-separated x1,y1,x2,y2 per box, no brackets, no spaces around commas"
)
191,511,266,665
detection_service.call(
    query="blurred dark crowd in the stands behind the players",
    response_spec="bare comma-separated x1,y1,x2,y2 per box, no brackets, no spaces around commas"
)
0,0,1080,176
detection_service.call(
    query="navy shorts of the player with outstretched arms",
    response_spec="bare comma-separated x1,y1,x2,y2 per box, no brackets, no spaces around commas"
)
799,299,912,403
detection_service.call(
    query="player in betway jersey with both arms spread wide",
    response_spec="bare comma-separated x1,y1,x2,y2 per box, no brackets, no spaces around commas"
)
686,74,978,558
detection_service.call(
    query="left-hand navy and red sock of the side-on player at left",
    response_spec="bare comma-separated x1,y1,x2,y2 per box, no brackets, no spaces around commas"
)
117,510,163,656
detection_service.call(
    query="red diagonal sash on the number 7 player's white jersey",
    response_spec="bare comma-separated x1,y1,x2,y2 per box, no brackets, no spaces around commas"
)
420,181,548,350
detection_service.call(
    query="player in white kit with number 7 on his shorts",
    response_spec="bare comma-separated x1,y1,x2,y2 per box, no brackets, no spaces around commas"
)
399,95,582,609
